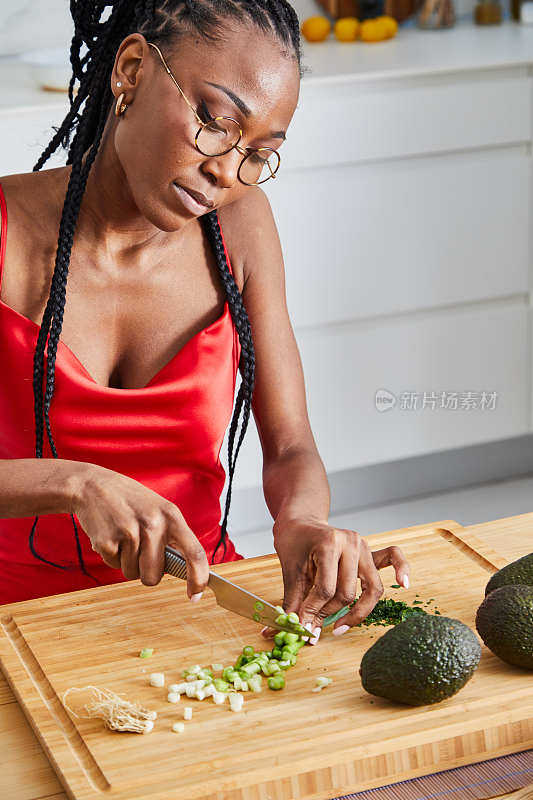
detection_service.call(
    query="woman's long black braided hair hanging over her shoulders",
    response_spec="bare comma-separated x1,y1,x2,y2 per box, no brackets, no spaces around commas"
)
29,0,305,584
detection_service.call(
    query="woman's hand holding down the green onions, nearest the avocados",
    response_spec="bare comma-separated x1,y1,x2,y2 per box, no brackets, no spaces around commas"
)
263,518,410,644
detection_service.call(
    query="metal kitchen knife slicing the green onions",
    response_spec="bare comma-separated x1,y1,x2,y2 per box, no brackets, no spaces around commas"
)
165,545,300,632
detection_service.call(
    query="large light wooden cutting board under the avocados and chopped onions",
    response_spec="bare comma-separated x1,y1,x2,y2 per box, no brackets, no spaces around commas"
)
0,520,533,800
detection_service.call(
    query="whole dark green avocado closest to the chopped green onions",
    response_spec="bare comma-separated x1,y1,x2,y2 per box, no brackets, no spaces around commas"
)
359,614,481,706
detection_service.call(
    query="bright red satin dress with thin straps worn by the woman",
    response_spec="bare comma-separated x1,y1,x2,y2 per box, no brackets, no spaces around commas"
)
0,184,243,603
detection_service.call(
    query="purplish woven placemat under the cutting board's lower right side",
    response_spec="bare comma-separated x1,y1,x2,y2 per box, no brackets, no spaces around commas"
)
336,750,533,800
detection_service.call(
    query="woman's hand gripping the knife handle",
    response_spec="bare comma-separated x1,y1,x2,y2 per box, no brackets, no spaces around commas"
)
70,464,209,600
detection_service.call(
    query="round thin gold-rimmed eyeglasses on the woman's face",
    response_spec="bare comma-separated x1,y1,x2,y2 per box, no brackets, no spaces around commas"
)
143,42,281,186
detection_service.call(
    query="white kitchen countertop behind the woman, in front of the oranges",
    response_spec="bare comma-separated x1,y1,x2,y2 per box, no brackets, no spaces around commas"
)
0,20,533,111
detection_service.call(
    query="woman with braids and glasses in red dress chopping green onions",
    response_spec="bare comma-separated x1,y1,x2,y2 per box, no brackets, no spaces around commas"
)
0,0,409,643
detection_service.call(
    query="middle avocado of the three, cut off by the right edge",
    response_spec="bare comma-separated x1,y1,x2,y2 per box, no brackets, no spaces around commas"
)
476,584,533,669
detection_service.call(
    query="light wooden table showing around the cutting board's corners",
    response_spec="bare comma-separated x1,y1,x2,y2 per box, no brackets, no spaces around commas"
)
0,512,533,800
